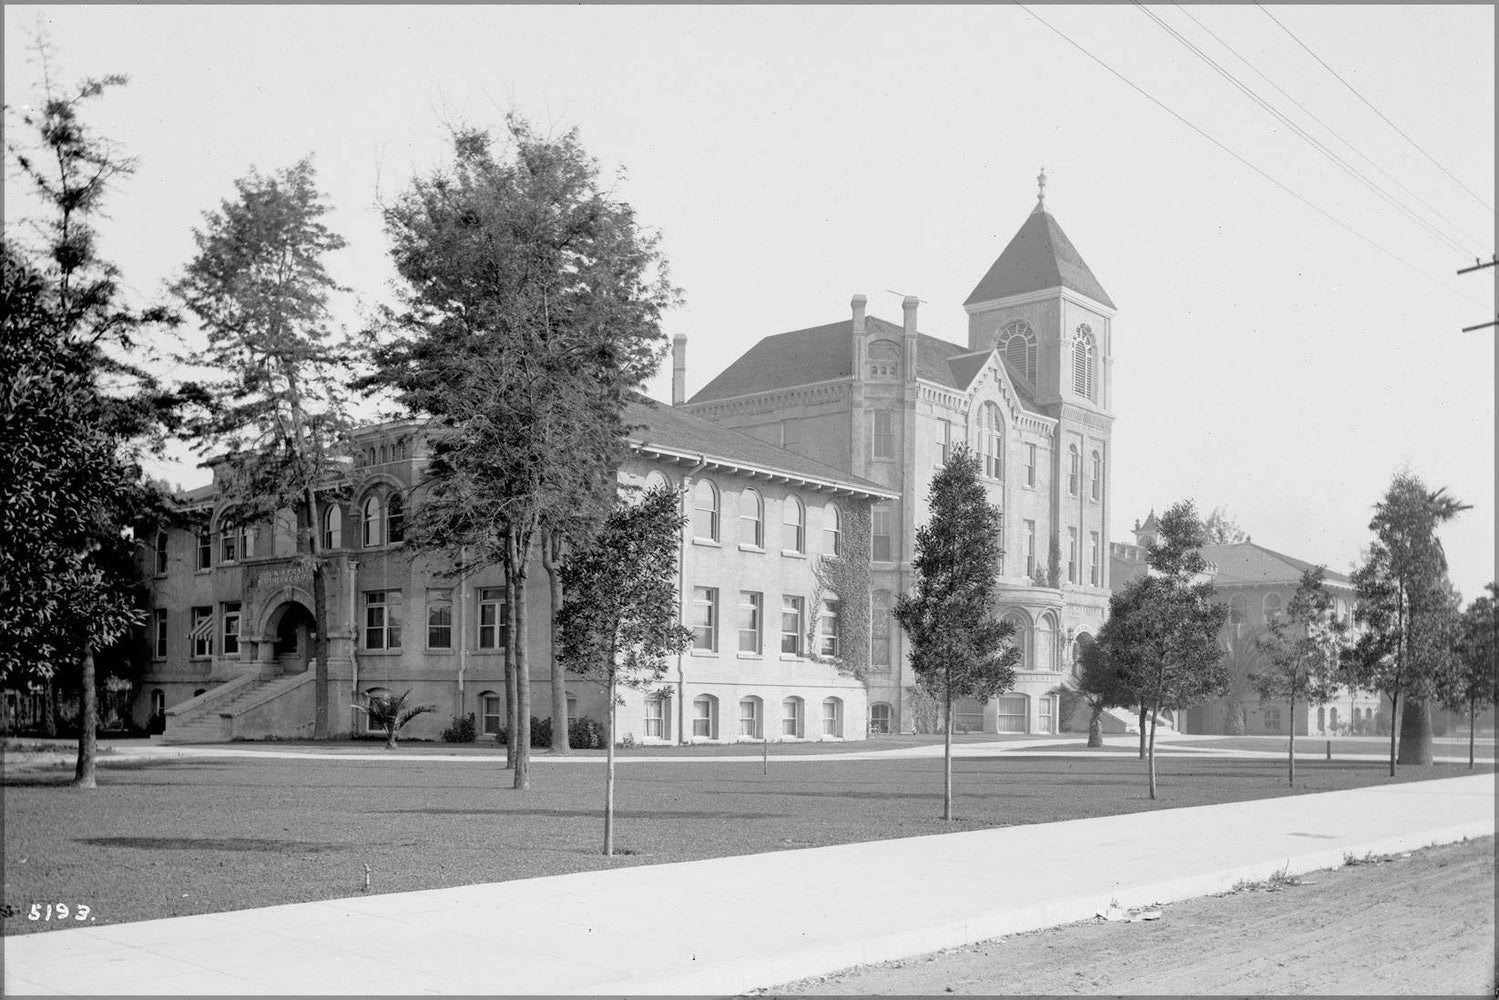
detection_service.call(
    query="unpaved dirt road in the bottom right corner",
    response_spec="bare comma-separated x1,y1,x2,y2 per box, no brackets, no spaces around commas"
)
764,837,1495,997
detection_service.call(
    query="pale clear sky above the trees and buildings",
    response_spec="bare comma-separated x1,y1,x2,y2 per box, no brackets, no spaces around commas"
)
3,4,1499,598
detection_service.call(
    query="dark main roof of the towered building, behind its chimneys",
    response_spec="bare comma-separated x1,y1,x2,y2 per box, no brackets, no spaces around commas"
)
690,316,988,403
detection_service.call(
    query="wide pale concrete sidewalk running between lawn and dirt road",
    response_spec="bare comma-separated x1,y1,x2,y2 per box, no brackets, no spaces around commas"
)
4,774,1495,996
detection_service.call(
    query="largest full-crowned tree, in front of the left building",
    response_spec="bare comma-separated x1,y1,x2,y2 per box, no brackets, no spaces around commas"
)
369,115,676,789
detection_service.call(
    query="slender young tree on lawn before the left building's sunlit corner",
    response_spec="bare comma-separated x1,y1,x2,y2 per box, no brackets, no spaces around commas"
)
558,486,693,856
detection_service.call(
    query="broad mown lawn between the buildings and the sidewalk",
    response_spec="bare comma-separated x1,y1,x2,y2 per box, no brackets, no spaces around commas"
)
3,745,1493,934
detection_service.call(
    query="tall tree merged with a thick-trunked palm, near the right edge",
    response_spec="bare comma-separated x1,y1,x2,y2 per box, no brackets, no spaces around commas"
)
1348,472,1469,777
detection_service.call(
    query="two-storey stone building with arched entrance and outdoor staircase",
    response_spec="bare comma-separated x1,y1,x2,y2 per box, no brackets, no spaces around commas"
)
135,405,893,742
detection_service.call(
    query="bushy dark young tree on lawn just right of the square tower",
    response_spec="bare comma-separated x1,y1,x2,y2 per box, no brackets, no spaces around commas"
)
1099,501,1229,799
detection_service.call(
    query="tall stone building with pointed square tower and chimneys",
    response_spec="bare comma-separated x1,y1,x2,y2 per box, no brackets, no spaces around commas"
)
686,180,1114,733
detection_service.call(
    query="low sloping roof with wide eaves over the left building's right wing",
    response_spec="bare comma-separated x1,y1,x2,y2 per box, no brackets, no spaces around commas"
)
625,400,895,498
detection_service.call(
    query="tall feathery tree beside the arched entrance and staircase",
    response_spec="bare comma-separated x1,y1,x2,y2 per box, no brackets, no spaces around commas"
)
172,159,351,739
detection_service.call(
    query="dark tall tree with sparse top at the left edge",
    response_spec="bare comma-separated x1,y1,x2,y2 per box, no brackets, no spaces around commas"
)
0,56,172,789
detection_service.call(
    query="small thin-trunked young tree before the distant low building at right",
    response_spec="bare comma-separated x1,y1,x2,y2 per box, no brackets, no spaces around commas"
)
1250,567,1345,786
